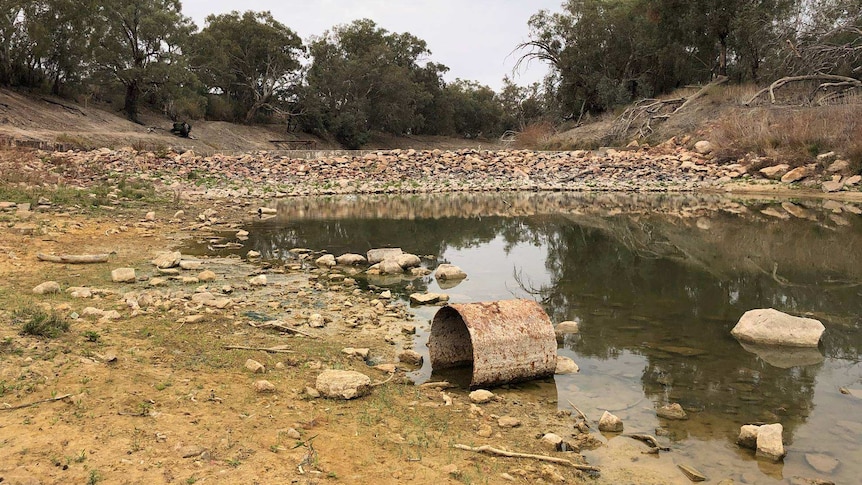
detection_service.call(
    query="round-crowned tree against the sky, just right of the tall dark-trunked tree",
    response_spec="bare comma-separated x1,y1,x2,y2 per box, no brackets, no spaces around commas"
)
192,11,305,123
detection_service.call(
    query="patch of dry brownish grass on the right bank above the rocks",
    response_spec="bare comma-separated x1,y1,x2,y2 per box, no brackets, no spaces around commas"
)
710,103,862,172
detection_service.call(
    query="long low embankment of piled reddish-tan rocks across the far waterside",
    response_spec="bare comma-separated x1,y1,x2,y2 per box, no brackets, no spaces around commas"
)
4,139,862,198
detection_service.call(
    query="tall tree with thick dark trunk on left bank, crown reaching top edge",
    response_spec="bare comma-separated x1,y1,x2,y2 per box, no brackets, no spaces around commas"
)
93,0,195,123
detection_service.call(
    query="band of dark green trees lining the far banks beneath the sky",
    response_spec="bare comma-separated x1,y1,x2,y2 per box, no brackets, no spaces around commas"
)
0,0,862,148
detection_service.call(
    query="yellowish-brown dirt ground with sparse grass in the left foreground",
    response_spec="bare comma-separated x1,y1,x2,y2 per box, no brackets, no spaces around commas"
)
0,190,696,484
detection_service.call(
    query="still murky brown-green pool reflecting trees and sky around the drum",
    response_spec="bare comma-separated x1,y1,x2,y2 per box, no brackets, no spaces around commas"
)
196,193,862,483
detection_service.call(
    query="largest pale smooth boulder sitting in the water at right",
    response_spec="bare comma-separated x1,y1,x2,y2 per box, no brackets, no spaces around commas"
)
730,308,825,347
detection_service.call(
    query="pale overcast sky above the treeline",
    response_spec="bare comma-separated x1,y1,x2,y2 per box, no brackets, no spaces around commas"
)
182,0,562,90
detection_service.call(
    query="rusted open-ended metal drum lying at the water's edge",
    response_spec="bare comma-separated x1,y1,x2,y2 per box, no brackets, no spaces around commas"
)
428,300,557,388
